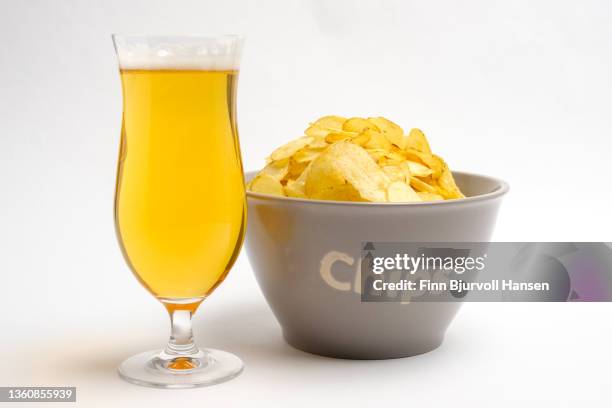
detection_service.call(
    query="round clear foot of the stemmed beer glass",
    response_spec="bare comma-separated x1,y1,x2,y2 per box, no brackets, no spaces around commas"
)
119,349,244,388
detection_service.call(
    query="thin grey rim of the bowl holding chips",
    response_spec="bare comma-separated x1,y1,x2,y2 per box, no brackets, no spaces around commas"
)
244,171,510,207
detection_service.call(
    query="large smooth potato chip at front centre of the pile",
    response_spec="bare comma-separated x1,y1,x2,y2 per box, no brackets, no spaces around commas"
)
306,142,389,202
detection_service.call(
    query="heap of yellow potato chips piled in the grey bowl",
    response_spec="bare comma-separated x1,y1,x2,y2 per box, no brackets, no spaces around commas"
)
247,116,464,202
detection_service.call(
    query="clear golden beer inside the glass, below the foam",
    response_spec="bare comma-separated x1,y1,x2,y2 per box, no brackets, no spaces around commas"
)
115,69,246,301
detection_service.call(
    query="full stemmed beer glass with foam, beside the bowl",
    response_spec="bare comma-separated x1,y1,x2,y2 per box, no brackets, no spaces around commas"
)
113,35,246,388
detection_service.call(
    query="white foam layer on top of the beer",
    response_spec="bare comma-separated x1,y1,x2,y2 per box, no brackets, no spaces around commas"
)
115,37,242,71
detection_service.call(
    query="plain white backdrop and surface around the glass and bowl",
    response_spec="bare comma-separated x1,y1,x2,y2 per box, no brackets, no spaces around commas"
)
0,0,612,407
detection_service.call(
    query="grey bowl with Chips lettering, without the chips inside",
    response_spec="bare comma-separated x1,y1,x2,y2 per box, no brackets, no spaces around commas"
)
246,172,508,359
